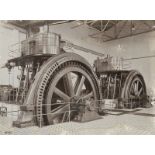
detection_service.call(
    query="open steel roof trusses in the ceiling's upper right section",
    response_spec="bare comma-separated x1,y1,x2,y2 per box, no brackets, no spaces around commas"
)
72,20,155,42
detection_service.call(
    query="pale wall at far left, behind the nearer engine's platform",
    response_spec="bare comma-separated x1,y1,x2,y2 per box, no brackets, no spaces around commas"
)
0,26,25,86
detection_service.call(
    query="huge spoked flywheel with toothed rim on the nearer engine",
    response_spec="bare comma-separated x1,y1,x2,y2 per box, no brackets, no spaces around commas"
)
35,53,100,125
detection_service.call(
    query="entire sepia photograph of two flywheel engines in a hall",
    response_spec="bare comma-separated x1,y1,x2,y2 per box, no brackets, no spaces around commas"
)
0,20,155,135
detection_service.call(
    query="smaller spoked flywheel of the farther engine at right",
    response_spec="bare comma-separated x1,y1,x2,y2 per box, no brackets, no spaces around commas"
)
121,70,147,108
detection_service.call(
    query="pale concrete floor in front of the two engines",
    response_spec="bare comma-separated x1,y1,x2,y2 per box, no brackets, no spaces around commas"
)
0,101,155,135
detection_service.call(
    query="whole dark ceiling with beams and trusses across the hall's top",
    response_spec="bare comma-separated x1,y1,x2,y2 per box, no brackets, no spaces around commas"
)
0,20,155,42
